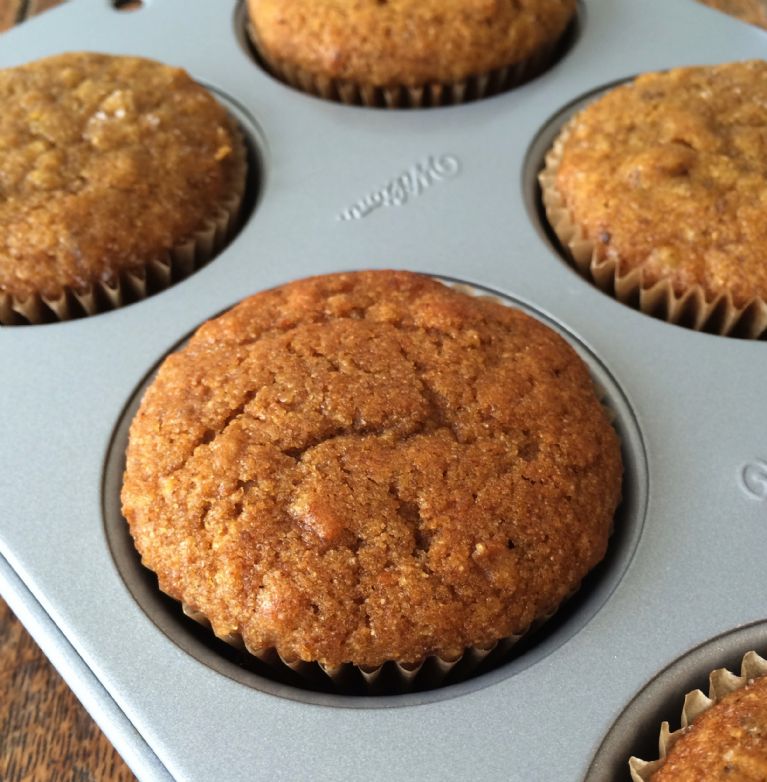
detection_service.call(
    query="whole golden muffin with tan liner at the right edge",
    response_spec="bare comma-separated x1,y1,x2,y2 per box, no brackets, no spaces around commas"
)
540,60,767,338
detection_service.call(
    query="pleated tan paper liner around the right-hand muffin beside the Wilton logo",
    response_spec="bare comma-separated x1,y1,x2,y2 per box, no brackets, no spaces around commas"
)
538,126,767,339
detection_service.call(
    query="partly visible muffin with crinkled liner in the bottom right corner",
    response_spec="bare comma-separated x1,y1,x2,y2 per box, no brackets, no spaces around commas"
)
630,652,767,782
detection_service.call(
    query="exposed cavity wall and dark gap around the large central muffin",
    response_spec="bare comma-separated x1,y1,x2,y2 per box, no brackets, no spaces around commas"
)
102,279,648,707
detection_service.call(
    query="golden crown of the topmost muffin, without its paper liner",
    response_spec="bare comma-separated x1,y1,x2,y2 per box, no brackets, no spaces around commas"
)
248,0,575,87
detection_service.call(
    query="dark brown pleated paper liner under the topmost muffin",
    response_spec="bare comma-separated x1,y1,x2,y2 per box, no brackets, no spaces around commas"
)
246,22,575,109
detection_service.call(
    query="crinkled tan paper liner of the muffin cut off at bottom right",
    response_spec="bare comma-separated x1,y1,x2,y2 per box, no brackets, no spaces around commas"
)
629,651,767,782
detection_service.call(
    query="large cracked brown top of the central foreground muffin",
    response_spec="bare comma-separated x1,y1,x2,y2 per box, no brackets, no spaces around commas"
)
122,271,622,666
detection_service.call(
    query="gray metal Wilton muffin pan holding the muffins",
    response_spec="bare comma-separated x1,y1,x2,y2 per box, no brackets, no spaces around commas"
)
0,0,767,782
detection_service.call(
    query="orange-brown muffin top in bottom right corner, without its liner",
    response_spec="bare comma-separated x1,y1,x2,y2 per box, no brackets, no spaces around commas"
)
650,676,767,782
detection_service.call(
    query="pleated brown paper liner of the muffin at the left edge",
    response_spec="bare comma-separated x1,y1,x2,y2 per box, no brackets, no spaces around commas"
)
0,120,247,326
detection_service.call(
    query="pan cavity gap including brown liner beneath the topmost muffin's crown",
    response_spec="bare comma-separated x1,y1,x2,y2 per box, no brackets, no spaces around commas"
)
234,0,585,109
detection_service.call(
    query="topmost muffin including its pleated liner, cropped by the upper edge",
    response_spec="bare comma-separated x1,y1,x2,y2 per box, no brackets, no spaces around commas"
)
248,0,576,107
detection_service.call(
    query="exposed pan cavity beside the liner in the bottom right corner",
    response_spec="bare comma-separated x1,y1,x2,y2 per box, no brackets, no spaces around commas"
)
584,622,767,782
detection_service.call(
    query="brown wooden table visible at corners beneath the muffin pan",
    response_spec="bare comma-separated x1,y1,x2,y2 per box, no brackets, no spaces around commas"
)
0,0,767,782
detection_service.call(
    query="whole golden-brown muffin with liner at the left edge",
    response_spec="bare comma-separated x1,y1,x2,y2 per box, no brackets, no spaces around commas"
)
0,52,246,323
